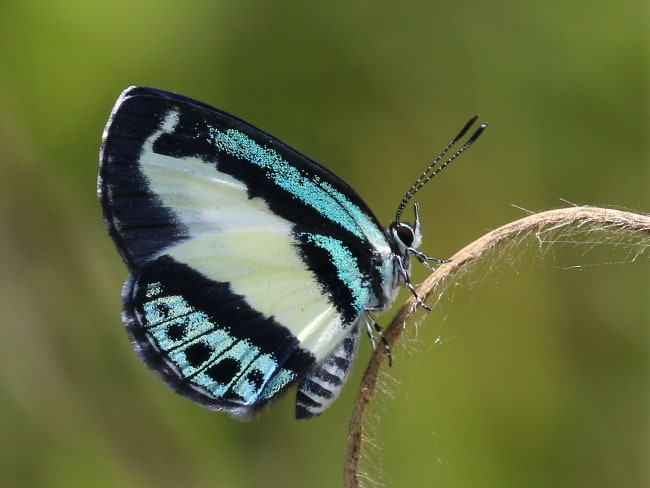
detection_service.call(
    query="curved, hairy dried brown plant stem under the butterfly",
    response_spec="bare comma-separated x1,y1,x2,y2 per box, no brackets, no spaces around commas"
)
344,207,650,488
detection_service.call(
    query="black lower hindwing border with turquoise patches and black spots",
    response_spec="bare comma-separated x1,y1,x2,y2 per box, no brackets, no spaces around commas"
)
124,255,315,417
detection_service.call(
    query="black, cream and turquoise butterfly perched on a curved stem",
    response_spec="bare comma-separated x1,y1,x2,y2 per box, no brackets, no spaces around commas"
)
97,87,486,419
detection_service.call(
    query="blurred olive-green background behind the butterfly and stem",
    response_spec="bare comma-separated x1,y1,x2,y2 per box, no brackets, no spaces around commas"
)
0,0,650,488
